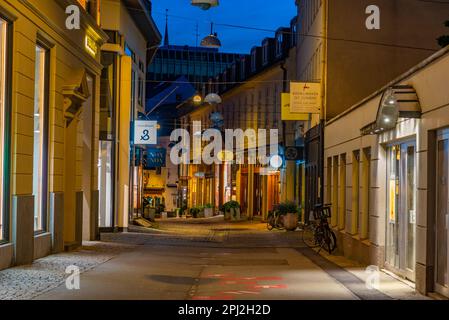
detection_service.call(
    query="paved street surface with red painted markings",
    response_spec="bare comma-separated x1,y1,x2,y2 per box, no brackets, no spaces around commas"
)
0,218,420,300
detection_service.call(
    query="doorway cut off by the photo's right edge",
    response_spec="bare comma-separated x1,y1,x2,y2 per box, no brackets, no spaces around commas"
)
435,130,449,297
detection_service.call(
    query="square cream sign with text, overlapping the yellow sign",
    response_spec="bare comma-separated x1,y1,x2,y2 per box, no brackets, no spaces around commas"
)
290,82,322,114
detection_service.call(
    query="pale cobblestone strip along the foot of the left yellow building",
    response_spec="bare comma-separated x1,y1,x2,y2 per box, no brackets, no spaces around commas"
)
0,242,130,300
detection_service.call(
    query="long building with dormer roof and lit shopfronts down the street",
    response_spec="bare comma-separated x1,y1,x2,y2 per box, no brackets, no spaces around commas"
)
180,19,302,219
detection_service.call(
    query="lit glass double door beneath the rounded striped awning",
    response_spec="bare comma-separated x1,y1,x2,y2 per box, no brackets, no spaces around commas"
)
385,142,416,281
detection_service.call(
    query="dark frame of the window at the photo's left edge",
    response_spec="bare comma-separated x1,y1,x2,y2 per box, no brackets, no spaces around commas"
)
0,12,14,245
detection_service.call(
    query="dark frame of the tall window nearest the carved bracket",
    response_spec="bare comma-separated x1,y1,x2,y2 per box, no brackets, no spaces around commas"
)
33,40,51,235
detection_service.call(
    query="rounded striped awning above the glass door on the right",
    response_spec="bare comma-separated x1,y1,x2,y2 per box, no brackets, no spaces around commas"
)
360,85,421,135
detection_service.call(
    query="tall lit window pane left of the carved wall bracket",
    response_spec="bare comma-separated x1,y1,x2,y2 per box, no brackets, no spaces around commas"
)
33,44,49,232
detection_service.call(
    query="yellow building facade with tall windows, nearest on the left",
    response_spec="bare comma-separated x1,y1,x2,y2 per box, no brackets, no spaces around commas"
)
0,0,107,268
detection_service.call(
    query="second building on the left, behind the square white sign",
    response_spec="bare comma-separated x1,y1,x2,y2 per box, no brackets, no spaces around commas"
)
98,0,161,231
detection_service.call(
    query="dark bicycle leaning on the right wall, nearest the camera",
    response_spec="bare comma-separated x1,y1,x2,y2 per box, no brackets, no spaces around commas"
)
302,205,337,254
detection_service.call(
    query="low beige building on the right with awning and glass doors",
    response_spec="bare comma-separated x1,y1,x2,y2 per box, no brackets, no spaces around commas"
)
325,48,449,296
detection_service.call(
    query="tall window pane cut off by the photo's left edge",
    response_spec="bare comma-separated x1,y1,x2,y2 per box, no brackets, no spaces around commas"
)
0,17,10,242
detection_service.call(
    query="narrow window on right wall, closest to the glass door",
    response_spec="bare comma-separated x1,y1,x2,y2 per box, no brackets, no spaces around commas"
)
360,148,371,239
